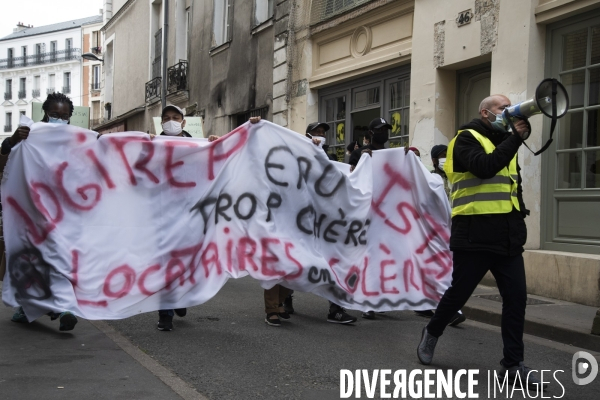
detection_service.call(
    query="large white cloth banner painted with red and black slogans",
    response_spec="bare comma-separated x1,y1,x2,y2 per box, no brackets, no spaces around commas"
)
2,121,452,319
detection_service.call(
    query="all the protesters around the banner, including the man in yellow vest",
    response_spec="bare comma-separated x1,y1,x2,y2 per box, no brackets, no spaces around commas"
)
0,88,543,388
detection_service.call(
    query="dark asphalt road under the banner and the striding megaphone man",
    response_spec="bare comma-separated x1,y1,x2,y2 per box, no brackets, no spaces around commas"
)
110,278,600,400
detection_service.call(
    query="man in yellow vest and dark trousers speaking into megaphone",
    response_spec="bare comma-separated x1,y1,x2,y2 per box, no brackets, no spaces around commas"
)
417,95,541,389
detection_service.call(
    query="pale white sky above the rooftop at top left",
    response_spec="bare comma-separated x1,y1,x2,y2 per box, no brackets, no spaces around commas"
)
0,0,104,38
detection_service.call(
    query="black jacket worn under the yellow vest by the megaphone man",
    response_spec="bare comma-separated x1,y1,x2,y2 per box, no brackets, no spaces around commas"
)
450,119,529,256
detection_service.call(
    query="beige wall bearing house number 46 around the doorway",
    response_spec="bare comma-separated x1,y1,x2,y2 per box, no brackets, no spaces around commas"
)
410,0,545,249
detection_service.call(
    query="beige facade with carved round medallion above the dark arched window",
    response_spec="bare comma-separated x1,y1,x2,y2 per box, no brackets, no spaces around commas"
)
288,0,415,133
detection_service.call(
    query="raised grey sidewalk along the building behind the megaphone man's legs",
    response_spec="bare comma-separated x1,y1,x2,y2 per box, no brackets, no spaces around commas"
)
462,285,600,351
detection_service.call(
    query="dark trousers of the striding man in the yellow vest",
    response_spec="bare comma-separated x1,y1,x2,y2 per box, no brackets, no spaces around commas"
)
427,251,527,368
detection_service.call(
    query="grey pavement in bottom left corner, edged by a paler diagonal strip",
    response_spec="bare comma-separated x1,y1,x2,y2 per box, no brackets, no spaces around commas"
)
0,285,203,400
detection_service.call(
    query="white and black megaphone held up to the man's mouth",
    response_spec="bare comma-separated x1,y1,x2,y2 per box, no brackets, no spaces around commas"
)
502,78,569,156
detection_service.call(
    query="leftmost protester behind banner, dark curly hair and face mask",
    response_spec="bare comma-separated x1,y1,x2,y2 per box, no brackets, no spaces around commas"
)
0,93,77,331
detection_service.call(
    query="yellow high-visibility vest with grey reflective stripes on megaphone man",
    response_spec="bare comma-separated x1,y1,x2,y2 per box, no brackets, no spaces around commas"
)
444,129,520,217
